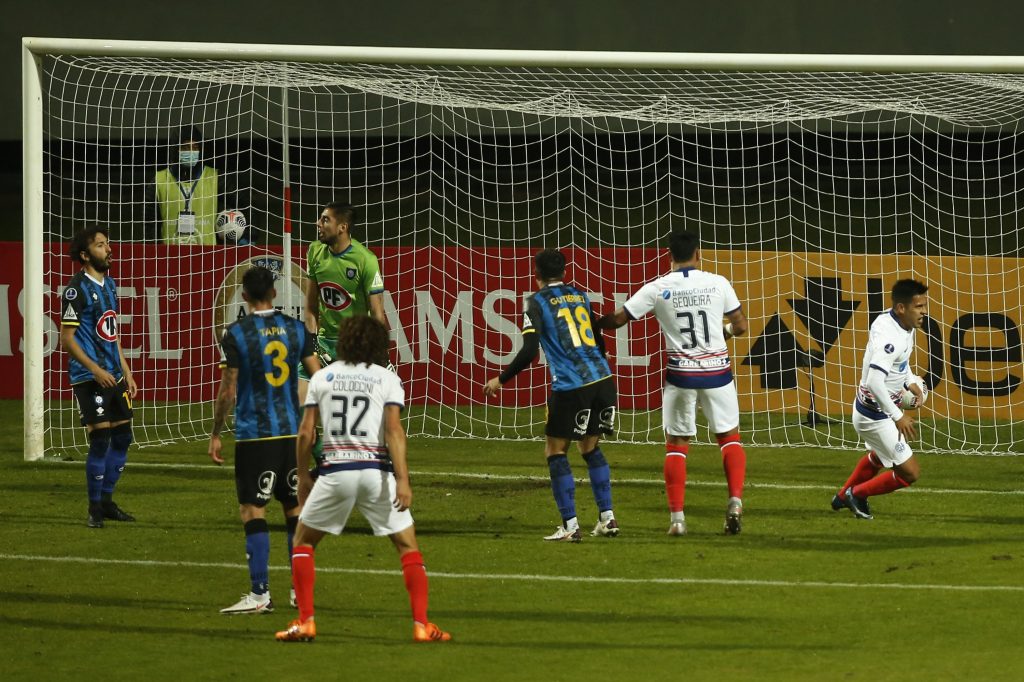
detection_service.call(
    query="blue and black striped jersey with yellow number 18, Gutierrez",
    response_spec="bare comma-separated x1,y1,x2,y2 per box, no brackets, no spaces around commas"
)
522,282,611,391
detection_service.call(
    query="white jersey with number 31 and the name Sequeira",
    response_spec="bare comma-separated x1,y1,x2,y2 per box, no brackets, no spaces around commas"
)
624,267,740,388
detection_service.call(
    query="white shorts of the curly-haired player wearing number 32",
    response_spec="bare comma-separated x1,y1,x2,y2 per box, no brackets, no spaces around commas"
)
299,469,413,536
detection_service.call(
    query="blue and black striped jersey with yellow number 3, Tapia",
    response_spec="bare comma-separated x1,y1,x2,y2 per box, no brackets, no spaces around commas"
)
220,309,313,440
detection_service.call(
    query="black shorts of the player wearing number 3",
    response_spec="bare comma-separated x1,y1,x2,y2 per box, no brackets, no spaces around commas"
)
234,438,299,509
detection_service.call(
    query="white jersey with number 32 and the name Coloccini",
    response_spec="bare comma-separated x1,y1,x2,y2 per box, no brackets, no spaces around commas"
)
306,360,406,474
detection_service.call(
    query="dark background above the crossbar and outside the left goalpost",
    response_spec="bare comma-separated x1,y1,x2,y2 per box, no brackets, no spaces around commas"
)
9,0,1024,246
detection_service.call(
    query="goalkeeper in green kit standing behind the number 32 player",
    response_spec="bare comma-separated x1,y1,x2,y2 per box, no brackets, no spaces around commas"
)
299,202,390,444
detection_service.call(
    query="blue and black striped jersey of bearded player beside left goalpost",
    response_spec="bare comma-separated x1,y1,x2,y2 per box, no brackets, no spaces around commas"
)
60,270,123,384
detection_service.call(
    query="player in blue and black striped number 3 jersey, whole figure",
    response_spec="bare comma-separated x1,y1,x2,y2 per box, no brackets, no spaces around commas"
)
208,266,319,614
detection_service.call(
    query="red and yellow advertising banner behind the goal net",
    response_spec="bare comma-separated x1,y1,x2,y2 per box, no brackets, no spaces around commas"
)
0,242,1024,419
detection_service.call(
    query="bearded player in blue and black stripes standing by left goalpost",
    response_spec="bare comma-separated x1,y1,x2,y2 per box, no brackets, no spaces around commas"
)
60,226,138,528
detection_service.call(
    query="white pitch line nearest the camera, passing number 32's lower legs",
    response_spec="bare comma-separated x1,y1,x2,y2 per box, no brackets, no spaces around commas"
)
0,554,1024,593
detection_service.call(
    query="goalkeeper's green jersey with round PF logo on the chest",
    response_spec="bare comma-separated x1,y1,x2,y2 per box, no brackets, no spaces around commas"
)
306,240,384,342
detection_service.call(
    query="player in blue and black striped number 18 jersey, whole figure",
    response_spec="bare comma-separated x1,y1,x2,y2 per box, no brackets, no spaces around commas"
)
483,249,618,543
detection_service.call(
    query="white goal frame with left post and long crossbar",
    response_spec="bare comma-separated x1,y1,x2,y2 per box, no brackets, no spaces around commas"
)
22,38,1024,461
